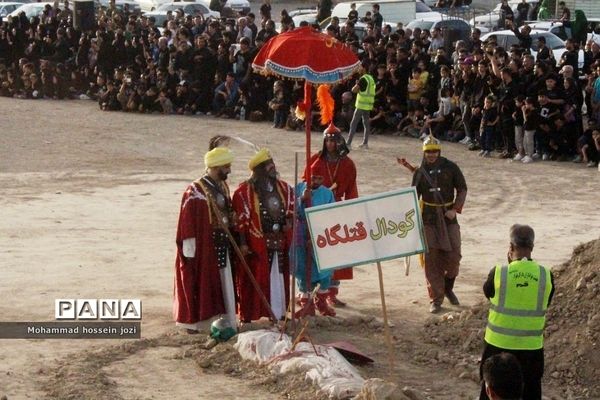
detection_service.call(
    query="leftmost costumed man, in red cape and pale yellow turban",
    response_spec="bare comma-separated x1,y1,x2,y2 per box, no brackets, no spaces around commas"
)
173,147,237,333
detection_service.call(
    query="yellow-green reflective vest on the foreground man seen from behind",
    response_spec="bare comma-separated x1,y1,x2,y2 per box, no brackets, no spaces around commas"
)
485,259,552,350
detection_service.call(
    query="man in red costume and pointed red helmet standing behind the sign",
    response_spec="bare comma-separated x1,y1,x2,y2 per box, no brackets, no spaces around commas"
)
304,124,358,307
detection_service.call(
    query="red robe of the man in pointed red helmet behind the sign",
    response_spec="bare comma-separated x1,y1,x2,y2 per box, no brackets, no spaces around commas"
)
304,152,358,280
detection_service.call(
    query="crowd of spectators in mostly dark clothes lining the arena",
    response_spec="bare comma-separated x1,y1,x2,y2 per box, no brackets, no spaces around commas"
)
0,0,600,166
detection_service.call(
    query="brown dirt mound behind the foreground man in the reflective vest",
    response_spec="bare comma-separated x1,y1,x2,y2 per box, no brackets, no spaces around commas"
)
415,239,600,399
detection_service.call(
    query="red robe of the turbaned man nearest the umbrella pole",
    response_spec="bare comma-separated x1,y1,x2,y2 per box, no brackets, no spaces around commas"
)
233,180,294,321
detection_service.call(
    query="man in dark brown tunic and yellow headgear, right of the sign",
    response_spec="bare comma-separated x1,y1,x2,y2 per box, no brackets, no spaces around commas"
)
412,135,467,314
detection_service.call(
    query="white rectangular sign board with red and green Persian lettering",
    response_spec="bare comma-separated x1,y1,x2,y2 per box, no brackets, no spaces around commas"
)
306,187,426,271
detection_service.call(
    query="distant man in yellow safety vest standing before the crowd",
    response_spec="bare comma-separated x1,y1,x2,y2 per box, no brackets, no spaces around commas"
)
347,60,375,149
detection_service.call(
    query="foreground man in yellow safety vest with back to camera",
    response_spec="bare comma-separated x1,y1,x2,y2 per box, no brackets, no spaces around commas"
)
479,224,554,400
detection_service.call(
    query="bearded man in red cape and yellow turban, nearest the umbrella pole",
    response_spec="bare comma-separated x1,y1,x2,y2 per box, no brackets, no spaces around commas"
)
233,149,294,323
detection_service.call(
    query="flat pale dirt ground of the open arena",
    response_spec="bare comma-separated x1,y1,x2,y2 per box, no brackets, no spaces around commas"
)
0,98,600,400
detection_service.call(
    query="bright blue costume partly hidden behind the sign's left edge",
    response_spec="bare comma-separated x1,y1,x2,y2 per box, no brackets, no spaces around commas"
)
290,182,335,292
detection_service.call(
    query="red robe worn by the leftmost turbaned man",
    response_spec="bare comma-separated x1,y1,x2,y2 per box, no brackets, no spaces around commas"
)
173,183,228,324
